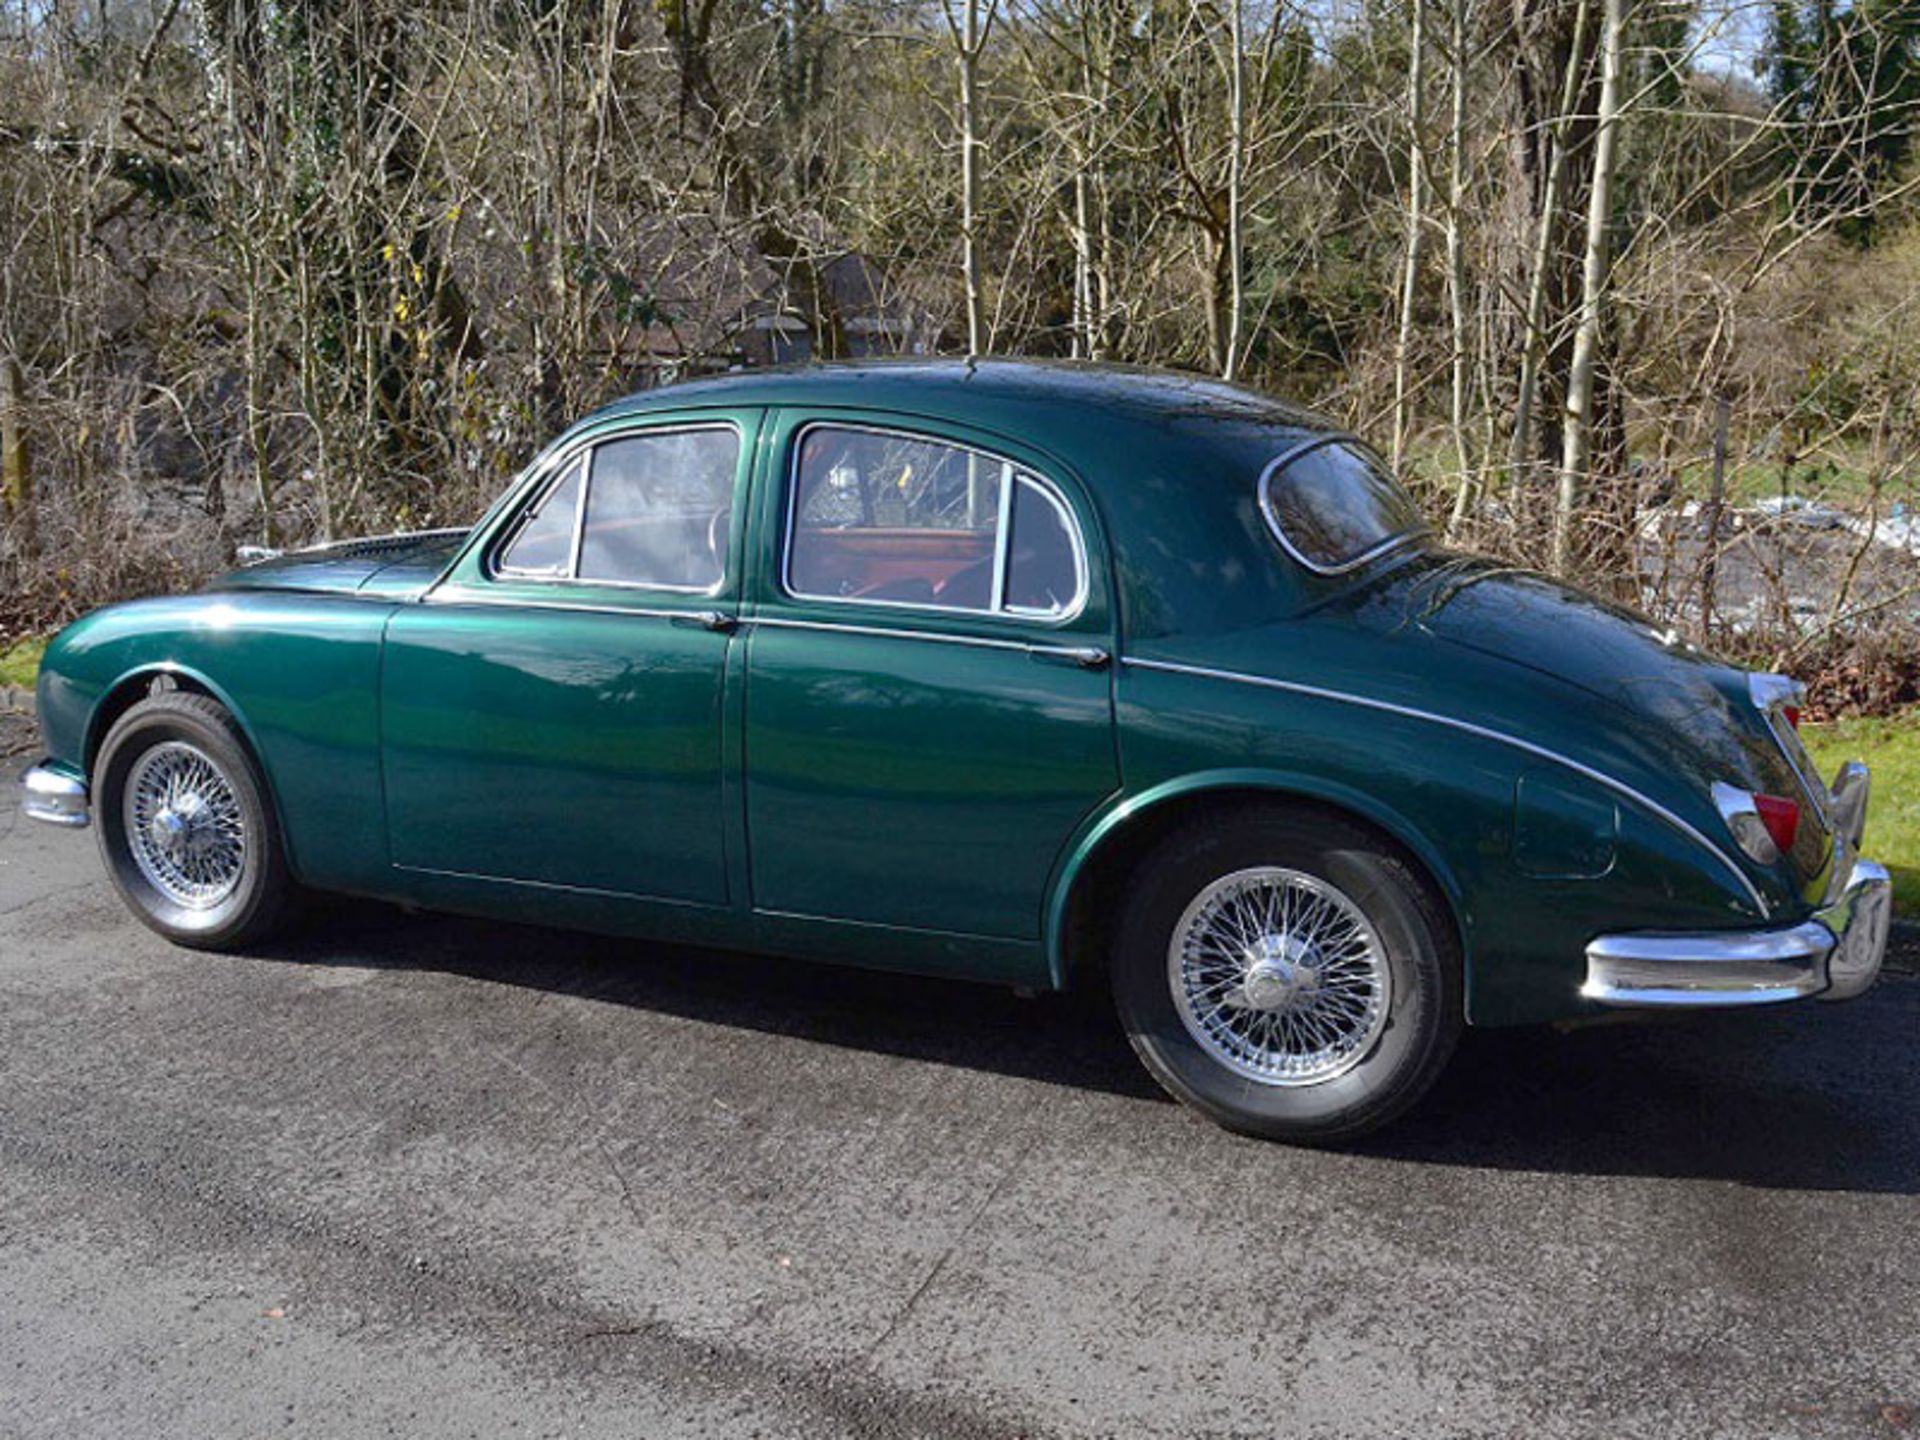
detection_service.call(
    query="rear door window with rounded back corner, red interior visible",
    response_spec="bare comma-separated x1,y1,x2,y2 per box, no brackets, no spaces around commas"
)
787,424,1085,618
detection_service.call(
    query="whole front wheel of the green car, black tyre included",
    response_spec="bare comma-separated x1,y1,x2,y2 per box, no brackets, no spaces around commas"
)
94,689,292,950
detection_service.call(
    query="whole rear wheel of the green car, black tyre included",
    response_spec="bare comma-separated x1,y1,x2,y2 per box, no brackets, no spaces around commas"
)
1112,808,1461,1142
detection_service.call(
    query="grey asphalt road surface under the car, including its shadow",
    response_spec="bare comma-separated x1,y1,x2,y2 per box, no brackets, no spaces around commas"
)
0,758,1920,1440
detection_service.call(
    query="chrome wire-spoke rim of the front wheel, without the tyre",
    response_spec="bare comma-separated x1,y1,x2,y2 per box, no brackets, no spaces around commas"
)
123,739,248,910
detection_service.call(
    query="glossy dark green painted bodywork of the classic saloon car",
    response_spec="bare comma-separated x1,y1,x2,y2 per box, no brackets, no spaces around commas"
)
40,361,1818,1023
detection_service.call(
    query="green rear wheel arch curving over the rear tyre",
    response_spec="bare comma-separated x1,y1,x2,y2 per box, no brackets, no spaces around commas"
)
1046,772,1473,989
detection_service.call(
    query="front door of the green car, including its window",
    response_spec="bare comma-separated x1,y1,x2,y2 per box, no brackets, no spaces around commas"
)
380,415,758,904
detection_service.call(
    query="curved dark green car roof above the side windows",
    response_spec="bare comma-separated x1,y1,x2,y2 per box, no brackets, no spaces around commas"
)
586,357,1338,453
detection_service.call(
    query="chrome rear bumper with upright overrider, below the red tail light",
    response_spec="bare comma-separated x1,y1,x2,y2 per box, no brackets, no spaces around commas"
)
1580,762,1893,1008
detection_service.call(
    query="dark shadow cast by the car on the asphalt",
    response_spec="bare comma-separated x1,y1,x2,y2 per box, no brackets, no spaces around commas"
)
263,900,1920,1194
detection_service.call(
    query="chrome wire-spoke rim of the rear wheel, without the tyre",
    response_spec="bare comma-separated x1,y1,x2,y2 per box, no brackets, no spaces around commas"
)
1167,866,1392,1085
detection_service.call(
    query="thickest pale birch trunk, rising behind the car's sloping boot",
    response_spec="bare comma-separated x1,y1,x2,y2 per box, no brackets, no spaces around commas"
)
1553,0,1626,572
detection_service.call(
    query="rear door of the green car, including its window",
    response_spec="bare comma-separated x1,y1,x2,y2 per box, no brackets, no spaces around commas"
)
745,413,1119,941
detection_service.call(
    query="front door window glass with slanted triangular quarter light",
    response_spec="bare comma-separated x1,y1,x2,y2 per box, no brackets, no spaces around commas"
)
493,426,739,591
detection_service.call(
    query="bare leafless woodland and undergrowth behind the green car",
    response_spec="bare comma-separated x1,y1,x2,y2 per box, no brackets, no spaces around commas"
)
0,0,1920,708
